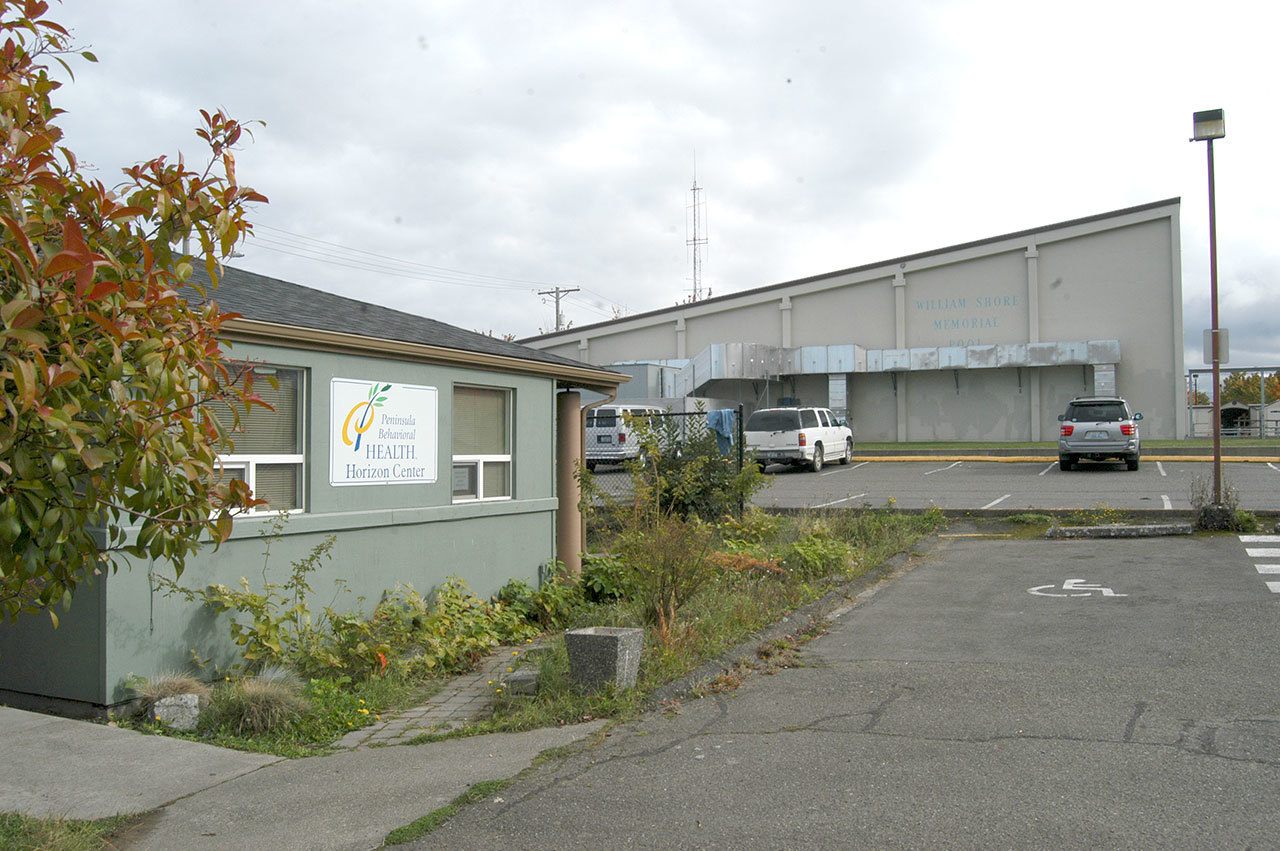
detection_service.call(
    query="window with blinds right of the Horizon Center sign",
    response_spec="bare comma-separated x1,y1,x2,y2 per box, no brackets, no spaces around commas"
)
453,385,512,502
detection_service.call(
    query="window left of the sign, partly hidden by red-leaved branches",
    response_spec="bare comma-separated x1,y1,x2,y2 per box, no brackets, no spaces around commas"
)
206,365,306,514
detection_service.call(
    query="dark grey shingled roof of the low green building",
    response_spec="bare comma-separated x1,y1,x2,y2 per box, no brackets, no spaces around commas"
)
195,266,604,378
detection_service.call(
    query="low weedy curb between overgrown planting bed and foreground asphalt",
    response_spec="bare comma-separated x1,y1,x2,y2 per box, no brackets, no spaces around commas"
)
644,534,941,710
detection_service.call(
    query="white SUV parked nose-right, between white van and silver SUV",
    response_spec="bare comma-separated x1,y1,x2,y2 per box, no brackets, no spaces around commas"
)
744,408,854,472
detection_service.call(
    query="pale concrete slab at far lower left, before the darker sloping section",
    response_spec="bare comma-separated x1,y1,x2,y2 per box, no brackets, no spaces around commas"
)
0,706,280,819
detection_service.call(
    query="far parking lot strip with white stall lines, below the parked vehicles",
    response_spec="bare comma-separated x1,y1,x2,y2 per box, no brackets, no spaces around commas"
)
754,459,1280,511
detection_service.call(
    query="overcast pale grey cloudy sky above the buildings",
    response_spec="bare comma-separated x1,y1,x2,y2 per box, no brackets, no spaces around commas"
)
54,0,1280,367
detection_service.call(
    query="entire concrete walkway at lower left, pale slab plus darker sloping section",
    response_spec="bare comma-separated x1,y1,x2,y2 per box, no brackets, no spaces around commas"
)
0,708,605,850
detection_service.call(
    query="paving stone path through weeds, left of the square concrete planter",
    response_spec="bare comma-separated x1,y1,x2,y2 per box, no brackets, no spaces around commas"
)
334,644,539,750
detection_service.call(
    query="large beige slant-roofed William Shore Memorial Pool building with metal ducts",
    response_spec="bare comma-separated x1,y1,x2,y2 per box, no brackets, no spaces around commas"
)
522,198,1187,440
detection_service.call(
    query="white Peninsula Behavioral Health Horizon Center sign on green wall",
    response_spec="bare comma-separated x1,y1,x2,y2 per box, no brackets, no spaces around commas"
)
329,379,439,486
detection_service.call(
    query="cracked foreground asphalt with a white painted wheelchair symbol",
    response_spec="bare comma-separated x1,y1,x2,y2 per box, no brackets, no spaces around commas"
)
419,532,1280,848
